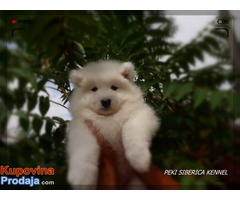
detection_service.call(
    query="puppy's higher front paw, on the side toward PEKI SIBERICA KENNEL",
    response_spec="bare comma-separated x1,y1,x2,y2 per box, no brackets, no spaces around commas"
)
126,148,151,172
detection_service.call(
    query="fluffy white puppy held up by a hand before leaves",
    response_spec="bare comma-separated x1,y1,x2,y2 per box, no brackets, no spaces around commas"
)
67,61,159,187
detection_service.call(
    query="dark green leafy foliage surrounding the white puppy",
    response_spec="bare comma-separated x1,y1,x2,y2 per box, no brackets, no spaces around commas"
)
0,11,240,189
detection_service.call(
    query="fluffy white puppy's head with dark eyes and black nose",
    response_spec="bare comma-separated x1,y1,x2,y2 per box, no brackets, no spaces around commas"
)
70,61,140,116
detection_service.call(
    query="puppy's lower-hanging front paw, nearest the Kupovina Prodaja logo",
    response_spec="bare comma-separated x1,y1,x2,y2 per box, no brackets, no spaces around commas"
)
67,166,97,189
